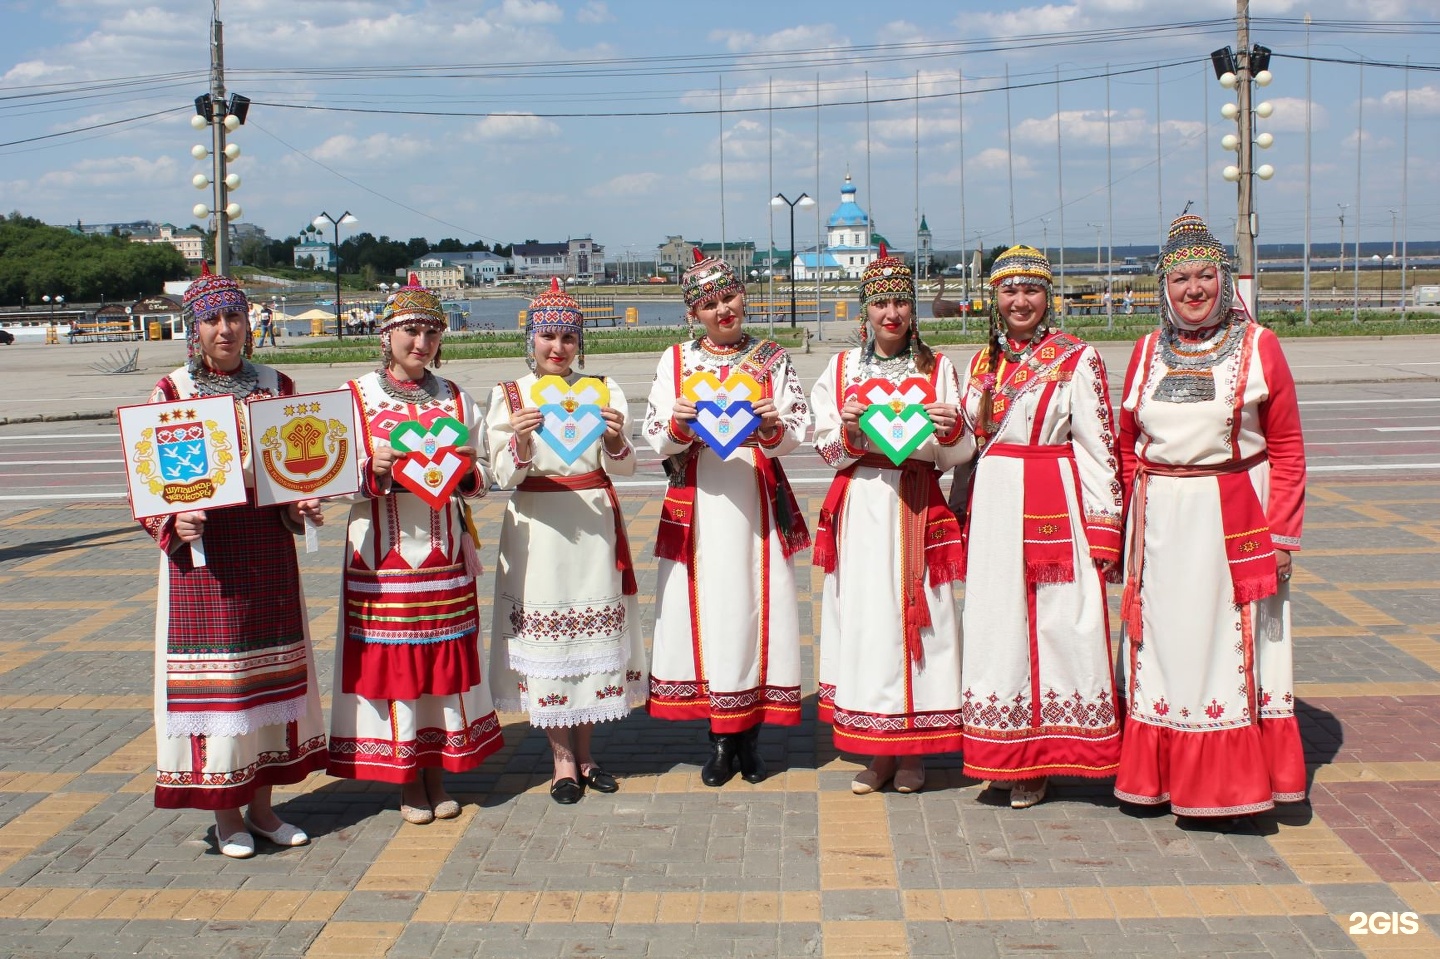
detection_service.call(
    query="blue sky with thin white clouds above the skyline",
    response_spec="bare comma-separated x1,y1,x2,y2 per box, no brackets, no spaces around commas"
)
0,0,1440,258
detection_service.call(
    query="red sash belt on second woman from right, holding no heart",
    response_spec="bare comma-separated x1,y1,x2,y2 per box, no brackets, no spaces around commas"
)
985,444,1080,583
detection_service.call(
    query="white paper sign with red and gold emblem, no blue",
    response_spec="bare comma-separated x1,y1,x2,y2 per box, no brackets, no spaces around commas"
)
246,390,360,505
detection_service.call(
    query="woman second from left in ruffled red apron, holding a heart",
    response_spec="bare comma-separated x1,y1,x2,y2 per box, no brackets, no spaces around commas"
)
328,274,503,825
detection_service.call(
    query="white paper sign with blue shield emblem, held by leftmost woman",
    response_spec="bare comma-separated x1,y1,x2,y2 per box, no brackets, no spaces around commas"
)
115,396,245,520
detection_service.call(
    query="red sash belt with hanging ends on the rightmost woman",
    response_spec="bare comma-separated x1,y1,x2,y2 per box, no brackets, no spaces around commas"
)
1120,452,1279,645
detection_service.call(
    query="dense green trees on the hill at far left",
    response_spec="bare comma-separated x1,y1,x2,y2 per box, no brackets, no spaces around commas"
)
0,213,189,307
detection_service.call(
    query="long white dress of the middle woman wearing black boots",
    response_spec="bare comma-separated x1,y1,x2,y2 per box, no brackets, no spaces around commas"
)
645,337,809,733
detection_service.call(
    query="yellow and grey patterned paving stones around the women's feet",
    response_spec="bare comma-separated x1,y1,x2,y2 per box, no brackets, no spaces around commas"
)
0,334,1440,959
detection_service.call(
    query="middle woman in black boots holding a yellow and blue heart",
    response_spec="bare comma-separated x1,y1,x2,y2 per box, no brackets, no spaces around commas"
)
645,251,809,786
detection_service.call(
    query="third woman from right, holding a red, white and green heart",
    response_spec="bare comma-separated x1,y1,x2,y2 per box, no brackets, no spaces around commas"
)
812,245,975,795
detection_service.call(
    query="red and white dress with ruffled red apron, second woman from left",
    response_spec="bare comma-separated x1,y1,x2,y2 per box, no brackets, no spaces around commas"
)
328,373,503,783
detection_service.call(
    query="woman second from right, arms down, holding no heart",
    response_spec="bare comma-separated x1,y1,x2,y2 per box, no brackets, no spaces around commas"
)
956,246,1120,809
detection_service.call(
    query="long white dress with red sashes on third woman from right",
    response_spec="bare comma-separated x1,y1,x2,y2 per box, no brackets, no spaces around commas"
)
811,348,975,756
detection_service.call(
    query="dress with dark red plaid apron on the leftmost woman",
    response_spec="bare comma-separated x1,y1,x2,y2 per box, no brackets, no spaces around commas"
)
141,364,325,809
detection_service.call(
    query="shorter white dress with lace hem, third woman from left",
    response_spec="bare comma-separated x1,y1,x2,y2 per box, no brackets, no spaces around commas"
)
485,373,649,726
